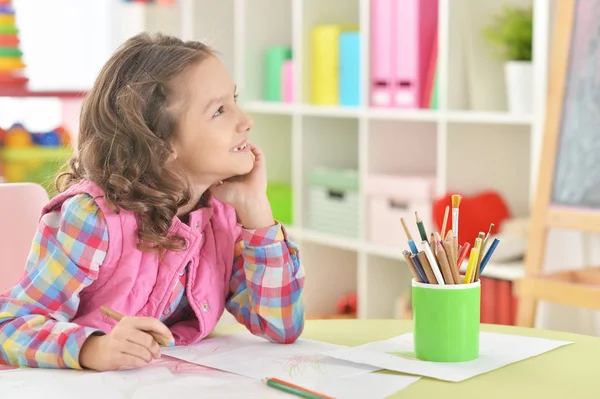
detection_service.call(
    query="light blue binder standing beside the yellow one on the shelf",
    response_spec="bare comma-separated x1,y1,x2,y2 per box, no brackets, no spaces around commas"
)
339,32,360,106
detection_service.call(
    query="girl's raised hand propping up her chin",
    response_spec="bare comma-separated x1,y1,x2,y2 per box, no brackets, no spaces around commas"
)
210,143,275,229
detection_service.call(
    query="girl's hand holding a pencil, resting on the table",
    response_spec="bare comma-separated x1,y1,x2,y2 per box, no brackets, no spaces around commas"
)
79,317,175,371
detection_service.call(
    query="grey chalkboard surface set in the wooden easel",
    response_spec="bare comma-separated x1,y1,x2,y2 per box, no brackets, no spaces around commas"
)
551,0,600,209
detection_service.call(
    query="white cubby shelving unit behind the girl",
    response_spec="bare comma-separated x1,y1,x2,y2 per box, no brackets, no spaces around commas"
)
137,0,553,318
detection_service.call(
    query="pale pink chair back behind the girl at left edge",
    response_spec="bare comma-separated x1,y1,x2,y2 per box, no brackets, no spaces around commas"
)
0,183,49,294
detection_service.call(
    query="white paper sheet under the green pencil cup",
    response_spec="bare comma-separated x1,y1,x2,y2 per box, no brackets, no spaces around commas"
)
325,332,572,382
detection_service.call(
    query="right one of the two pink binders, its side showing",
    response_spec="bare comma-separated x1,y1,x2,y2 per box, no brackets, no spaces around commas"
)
392,0,438,108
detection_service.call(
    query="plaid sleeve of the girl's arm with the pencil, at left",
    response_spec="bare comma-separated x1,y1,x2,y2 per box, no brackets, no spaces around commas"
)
0,194,108,369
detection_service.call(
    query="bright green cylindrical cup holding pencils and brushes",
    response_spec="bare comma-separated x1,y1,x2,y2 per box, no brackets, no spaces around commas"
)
412,280,481,362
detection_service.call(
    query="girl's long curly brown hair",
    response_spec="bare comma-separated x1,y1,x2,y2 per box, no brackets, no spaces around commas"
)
56,33,214,250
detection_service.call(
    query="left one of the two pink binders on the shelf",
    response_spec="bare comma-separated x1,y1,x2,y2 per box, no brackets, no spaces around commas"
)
370,0,395,107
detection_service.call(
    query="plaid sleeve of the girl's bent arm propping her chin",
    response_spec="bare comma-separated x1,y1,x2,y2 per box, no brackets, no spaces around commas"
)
227,223,304,343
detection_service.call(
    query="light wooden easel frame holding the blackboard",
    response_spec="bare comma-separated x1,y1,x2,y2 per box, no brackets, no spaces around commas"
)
515,0,600,327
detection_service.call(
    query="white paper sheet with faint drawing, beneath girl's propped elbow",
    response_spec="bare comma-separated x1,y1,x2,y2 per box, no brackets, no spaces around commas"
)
162,333,378,389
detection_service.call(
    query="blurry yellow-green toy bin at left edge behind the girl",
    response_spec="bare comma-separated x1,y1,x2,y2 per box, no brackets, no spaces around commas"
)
1,146,73,197
